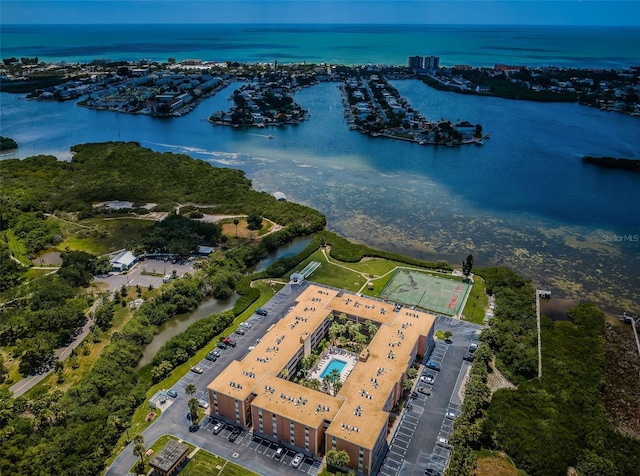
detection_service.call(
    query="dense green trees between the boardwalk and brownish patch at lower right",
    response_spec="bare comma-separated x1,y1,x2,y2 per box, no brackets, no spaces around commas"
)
482,303,640,476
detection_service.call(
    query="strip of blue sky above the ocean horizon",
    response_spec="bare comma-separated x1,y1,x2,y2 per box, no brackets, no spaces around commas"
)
0,0,640,26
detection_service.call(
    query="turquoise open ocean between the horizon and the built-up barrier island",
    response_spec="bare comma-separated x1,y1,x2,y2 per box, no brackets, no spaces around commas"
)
0,25,640,68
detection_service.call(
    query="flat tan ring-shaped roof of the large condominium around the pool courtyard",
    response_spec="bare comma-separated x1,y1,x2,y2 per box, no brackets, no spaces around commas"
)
208,285,435,448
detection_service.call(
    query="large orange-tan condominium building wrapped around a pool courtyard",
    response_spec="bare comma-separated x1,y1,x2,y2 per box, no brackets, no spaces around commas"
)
208,285,435,474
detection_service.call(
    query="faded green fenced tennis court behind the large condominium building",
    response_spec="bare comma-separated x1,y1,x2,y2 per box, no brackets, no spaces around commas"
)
380,268,471,316
